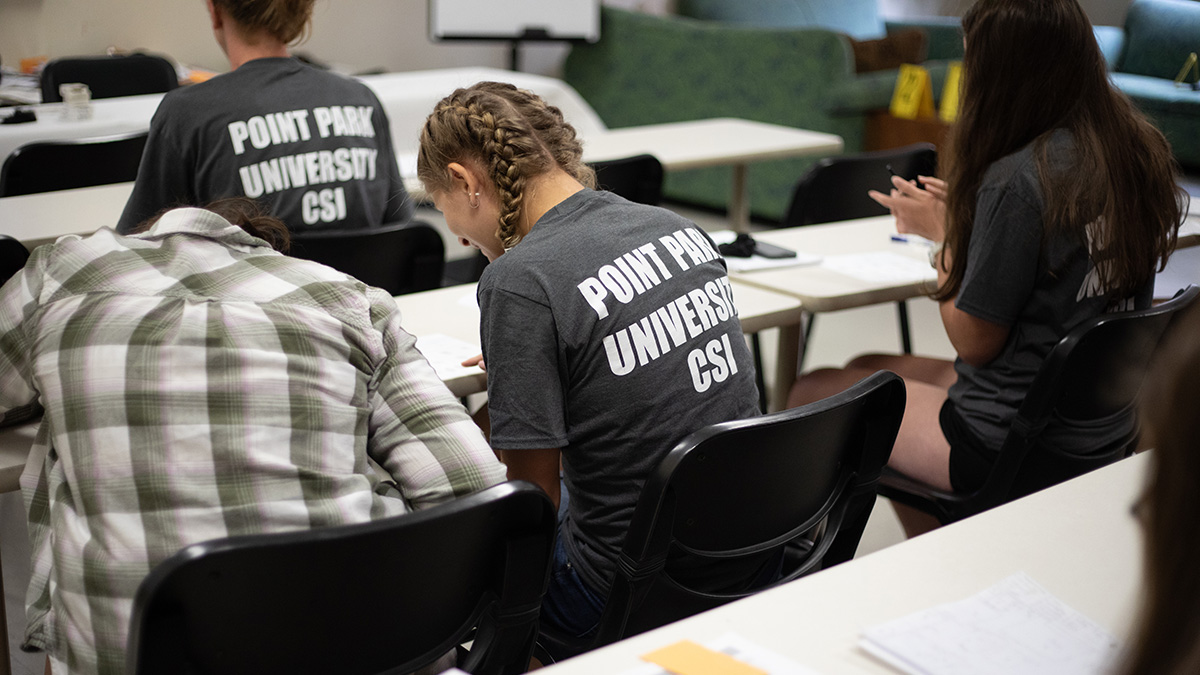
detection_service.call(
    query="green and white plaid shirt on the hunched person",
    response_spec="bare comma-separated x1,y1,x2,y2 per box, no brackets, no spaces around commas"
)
0,209,504,673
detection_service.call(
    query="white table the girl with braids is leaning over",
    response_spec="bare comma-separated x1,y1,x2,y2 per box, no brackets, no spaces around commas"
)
396,281,803,396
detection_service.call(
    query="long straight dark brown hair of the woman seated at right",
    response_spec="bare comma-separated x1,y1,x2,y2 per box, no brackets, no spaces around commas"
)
934,0,1187,300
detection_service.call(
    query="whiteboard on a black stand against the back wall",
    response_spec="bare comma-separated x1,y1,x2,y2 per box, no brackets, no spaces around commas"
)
430,0,600,42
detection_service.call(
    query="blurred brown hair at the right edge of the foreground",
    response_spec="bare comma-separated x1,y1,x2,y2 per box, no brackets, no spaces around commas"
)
1124,305,1200,675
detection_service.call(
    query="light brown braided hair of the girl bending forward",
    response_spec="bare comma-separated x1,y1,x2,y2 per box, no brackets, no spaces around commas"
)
416,82,595,249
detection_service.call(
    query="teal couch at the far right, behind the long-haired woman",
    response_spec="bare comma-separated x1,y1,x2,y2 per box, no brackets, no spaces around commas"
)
1099,0,1200,169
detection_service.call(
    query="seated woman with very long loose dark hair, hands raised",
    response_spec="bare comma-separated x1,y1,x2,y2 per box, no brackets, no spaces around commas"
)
788,0,1186,530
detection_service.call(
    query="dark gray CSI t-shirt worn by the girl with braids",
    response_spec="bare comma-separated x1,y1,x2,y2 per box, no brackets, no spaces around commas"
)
479,190,758,593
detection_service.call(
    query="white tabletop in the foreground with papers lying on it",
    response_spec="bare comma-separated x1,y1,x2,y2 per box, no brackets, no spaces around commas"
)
544,446,1147,675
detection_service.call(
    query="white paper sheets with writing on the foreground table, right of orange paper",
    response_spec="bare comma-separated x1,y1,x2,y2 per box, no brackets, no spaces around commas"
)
859,573,1120,675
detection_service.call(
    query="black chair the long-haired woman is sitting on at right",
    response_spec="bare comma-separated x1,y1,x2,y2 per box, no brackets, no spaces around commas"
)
880,286,1200,524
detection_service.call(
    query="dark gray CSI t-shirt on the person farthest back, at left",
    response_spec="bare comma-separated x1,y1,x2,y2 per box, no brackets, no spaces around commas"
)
116,58,413,233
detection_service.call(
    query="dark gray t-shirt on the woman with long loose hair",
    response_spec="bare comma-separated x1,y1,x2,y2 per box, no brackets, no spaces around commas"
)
949,130,1153,452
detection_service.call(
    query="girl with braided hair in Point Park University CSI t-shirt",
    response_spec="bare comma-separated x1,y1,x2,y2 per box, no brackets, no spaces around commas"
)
418,82,763,635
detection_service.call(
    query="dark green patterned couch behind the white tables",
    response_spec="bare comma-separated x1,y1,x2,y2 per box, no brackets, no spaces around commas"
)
564,2,961,220
